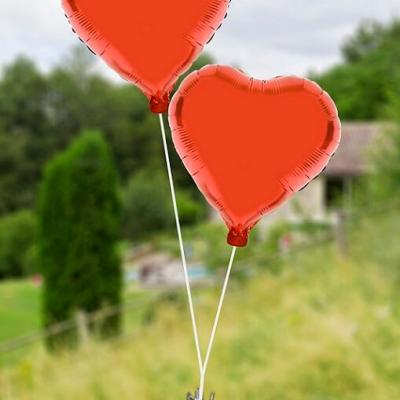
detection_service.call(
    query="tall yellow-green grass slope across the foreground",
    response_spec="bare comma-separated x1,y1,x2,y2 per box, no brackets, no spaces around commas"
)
0,211,400,400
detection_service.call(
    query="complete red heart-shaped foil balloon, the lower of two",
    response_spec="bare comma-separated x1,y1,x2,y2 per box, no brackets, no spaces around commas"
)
169,65,340,246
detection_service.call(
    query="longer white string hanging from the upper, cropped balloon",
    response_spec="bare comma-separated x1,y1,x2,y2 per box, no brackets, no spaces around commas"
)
158,114,203,376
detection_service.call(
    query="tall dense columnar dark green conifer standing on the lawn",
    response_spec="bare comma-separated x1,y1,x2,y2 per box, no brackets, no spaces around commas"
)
39,132,122,346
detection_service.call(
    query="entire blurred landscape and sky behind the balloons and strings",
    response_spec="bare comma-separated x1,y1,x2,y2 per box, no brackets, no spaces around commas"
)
0,0,400,400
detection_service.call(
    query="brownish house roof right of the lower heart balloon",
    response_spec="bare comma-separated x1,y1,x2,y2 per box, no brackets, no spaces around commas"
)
325,122,381,176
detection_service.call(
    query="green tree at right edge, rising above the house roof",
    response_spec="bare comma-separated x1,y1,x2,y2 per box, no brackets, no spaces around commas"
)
311,20,400,120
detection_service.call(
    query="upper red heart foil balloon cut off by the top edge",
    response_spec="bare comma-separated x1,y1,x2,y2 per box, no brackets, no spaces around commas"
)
63,0,229,113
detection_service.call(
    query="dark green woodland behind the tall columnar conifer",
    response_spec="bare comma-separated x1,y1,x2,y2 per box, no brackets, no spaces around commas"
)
0,46,212,219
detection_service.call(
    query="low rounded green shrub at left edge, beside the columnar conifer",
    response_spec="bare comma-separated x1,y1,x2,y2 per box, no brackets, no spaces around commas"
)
0,210,36,279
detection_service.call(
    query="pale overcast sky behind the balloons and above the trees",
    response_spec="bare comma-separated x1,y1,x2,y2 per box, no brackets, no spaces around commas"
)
0,0,400,78
